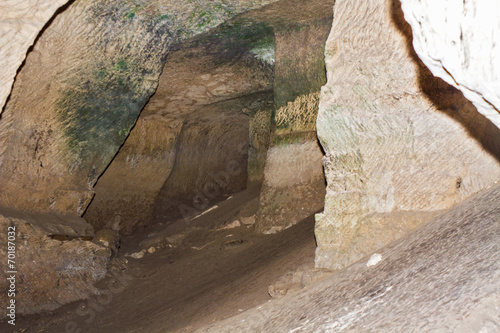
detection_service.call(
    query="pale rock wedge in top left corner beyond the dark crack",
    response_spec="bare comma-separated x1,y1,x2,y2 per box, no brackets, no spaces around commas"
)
0,0,68,115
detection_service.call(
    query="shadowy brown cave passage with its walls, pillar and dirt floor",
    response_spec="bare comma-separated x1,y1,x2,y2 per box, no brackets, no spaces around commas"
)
0,1,332,332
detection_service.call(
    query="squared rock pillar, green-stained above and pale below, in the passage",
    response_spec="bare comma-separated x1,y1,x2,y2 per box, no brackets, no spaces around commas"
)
256,8,332,233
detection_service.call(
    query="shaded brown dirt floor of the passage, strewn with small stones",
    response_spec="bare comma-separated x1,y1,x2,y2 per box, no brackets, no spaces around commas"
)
0,188,316,332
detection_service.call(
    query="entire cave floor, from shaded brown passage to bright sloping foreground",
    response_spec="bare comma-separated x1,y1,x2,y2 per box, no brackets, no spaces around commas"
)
0,186,500,333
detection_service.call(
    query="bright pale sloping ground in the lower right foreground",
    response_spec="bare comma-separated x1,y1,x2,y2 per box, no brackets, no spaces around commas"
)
199,186,500,333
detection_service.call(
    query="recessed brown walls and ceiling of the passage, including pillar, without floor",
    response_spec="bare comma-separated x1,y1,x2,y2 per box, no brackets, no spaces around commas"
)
85,0,332,232
